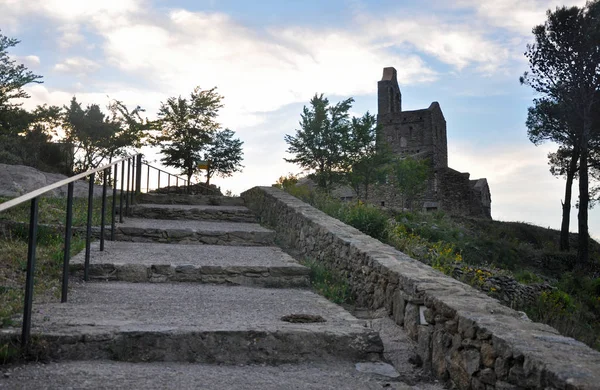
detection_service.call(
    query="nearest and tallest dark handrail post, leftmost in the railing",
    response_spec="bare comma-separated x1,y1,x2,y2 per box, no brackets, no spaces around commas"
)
21,198,39,349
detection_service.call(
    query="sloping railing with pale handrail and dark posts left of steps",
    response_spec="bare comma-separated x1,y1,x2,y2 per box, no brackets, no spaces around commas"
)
0,154,142,348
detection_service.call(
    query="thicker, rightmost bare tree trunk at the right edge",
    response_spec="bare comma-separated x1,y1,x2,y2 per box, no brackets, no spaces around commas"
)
577,110,591,265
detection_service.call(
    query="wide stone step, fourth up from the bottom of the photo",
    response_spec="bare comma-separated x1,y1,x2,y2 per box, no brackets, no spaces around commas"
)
115,218,275,246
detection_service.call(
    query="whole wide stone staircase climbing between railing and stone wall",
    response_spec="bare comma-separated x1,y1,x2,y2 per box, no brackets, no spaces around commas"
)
0,195,440,389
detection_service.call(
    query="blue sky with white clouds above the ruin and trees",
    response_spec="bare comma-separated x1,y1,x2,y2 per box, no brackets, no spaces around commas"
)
0,0,600,238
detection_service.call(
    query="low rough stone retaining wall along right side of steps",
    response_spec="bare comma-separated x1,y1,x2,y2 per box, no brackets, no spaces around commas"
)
242,187,600,390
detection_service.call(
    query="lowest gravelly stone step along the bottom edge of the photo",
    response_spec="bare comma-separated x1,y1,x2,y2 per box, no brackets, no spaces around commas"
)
0,361,408,390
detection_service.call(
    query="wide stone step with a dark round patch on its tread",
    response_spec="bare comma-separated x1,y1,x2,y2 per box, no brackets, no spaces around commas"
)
0,282,383,364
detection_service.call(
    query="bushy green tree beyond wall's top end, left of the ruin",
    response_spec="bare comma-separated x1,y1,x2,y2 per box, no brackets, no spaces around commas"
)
284,94,354,189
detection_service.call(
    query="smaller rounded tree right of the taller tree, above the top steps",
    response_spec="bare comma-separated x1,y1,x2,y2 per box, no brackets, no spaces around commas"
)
204,129,244,185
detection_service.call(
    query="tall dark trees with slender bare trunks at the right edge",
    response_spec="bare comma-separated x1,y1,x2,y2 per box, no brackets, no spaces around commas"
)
520,0,600,264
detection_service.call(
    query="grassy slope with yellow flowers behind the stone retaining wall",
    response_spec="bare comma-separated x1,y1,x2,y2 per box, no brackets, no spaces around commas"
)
286,186,600,350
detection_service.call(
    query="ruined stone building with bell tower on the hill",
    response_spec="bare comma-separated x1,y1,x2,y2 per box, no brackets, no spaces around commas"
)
369,68,492,218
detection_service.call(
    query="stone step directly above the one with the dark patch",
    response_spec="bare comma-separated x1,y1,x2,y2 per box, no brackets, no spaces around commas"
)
70,241,310,288
